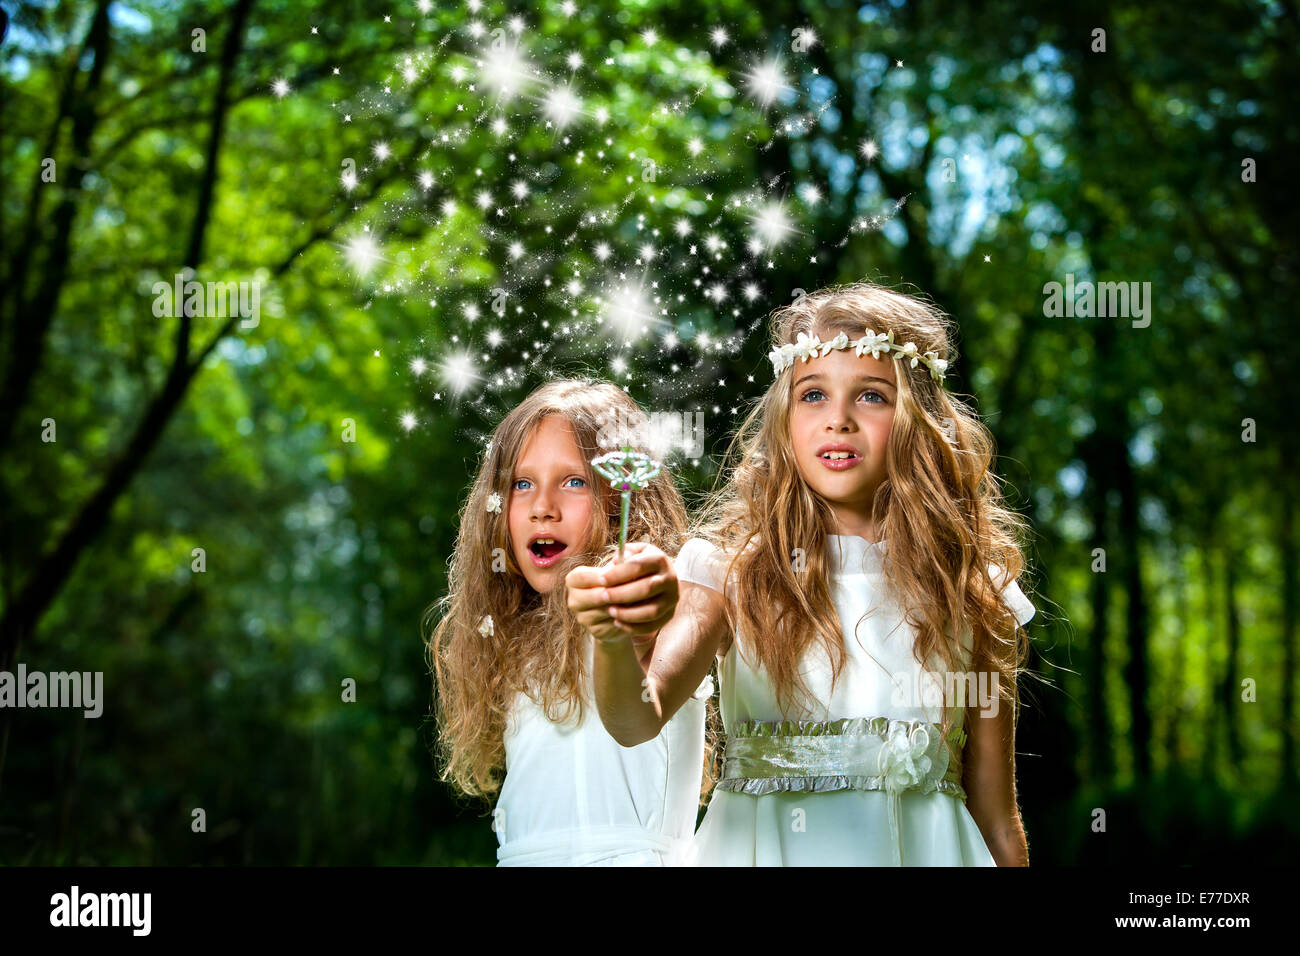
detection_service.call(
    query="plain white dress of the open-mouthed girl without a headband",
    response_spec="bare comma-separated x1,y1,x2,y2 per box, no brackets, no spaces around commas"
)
493,641,712,866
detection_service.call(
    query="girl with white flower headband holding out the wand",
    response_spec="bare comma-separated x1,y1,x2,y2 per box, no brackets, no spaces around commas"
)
571,282,1035,866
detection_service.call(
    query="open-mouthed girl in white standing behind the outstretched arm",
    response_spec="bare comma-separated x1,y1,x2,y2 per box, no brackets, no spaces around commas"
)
426,380,711,866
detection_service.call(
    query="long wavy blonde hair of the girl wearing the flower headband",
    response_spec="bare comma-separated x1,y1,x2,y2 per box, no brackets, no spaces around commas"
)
692,282,1028,736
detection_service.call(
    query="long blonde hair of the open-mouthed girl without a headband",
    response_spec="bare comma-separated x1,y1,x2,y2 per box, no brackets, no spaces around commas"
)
423,377,712,799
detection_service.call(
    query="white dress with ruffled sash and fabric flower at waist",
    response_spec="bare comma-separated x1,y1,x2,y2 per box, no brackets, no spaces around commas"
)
675,535,1035,866
